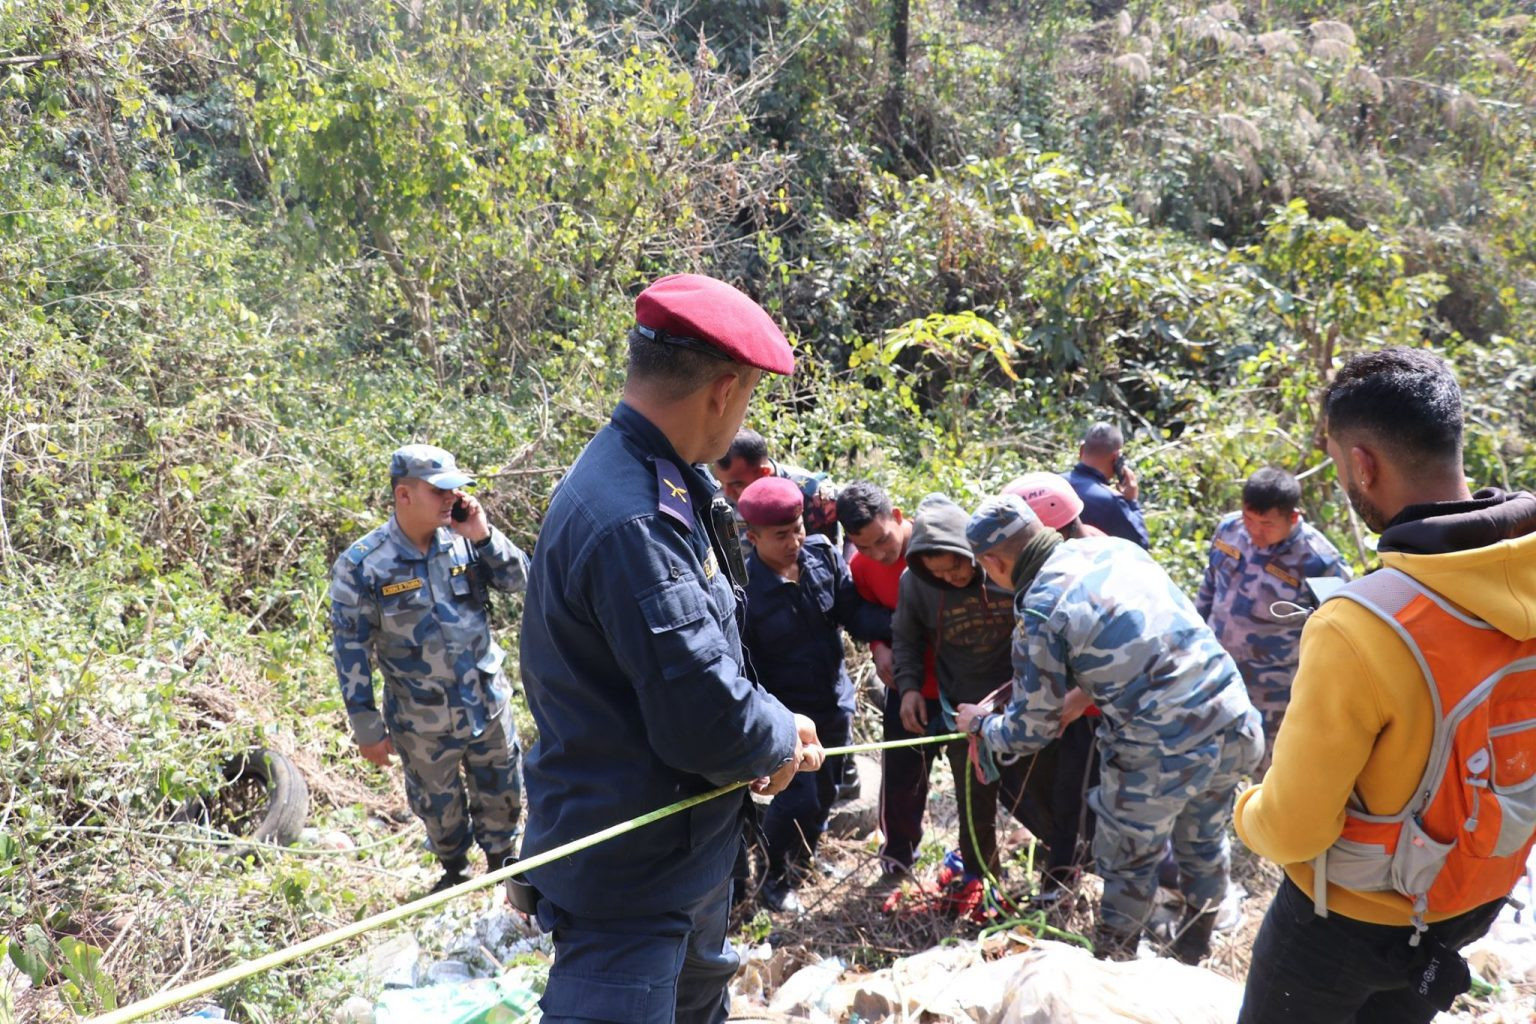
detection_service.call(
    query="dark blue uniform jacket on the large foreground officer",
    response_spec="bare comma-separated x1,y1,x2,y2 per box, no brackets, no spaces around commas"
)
522,402,796,917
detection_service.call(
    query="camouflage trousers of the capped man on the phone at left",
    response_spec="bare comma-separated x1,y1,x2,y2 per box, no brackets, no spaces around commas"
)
389,681,522,867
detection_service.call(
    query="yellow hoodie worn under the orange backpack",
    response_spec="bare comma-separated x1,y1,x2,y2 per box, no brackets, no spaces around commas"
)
1233,503,1536,924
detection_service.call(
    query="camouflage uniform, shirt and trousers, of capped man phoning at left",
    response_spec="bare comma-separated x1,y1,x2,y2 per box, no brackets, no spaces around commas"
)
330,516,527,866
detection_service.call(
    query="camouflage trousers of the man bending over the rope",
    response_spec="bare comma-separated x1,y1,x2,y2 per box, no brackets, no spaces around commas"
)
1087,711,1264,933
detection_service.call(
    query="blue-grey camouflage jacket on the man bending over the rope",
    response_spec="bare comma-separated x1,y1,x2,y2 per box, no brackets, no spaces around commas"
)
982,537,1252,768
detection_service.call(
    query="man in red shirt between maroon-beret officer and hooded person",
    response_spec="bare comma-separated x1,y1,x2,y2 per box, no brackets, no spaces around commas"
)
837,481,940,881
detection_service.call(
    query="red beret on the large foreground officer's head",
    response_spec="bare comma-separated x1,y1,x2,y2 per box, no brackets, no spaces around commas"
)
634,273,794,373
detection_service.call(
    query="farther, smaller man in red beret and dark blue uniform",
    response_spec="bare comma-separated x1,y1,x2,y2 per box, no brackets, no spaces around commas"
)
736,476,891,913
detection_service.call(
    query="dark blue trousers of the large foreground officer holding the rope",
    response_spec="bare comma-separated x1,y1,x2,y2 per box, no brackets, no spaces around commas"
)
539,878,740,1024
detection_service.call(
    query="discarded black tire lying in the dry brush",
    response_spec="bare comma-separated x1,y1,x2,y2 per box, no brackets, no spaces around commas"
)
172,748,309,846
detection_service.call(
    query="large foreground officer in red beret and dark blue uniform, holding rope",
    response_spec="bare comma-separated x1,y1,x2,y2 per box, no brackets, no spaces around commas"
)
522,275,823,1024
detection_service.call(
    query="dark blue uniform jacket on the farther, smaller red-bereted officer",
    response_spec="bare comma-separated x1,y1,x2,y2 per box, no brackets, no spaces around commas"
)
742,534,891,717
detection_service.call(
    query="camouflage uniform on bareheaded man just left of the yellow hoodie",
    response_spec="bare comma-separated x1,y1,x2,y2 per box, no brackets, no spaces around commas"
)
1195,513,1350,769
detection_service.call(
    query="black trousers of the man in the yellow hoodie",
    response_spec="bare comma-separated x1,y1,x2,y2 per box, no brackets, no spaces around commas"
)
1238,878,1504,1024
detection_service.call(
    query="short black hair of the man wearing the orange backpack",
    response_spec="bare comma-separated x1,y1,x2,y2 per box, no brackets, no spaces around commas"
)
1322,347,1462,464
